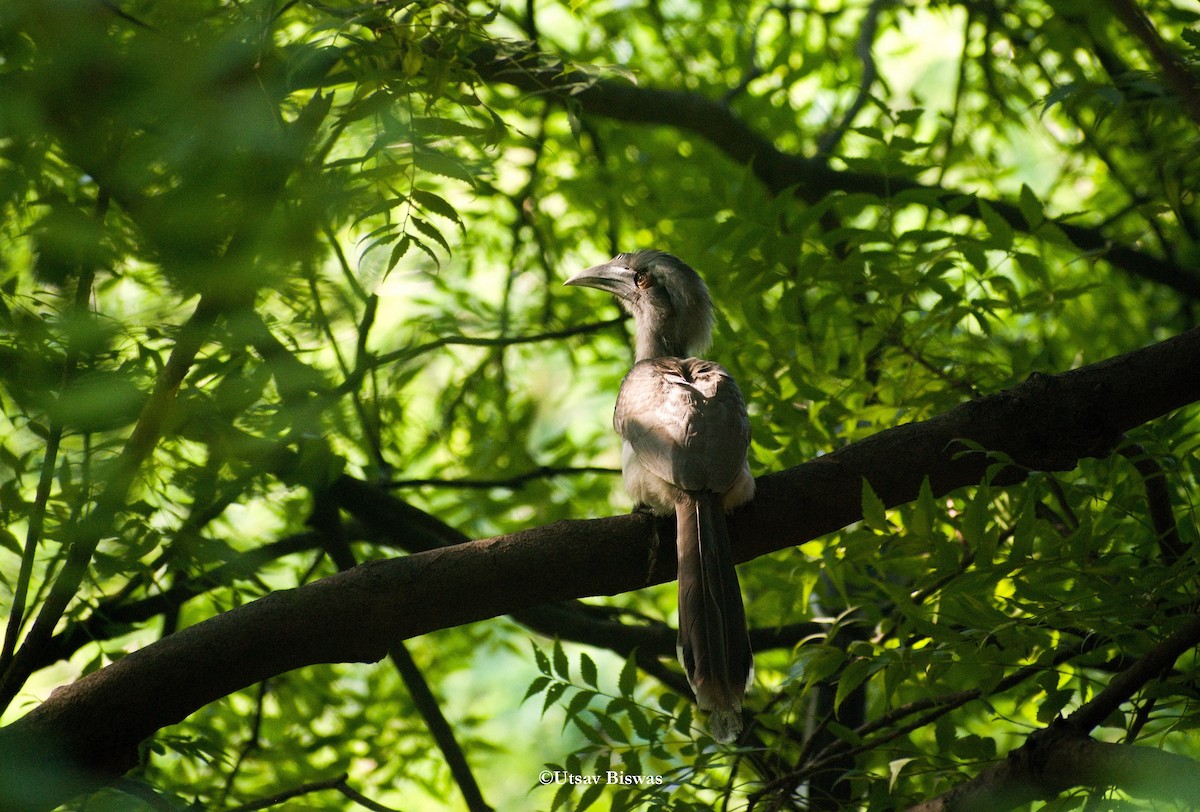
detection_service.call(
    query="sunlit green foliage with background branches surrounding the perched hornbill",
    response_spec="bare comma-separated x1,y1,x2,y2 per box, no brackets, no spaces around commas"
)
0,0,1200,810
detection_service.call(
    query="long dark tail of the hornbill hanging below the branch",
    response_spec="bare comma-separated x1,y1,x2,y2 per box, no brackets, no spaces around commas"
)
676,492,754,742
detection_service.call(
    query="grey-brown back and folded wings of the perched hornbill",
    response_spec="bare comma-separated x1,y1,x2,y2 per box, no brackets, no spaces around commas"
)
613,357,750,493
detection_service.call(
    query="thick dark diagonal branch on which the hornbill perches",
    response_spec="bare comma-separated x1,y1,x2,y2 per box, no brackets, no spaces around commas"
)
0,329,1200,810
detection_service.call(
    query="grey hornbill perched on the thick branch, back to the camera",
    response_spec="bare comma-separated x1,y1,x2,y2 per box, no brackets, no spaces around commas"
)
565,251,754,741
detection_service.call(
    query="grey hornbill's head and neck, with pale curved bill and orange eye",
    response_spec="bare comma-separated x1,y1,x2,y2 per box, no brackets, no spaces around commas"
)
564,251,713,361
